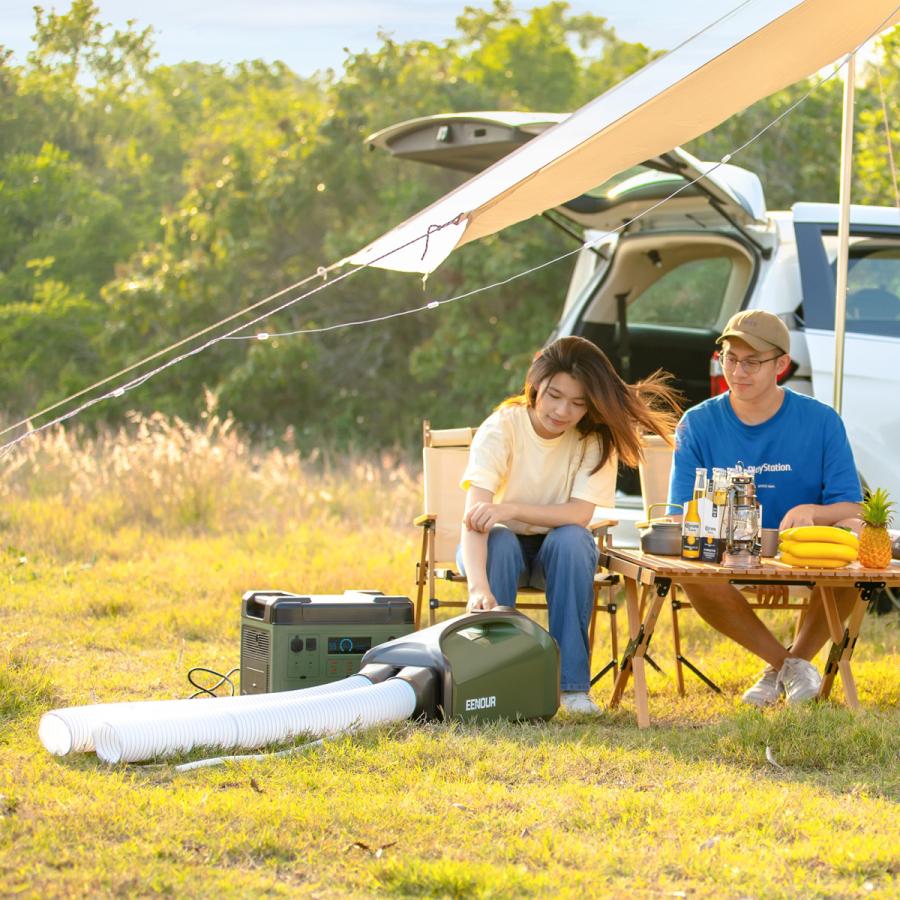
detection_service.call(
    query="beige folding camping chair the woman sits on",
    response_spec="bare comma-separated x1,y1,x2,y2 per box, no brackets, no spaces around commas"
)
415,419,618,680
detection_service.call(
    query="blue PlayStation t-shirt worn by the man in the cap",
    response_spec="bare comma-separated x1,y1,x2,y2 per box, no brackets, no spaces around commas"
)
669,389,862,528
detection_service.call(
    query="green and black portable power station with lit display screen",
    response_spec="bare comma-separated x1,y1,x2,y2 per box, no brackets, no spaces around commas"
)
241,591,415,694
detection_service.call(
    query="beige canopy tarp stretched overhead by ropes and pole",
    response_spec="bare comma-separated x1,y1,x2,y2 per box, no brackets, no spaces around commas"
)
345,0,900,273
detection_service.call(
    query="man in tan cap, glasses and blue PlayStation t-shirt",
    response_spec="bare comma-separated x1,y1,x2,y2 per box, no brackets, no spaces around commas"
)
669,309,862,706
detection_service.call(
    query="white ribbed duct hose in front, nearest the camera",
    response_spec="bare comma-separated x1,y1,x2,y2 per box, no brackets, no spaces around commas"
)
93,678,416,763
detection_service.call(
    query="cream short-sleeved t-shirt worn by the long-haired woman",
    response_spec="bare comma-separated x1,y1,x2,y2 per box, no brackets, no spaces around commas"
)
460,405,617,534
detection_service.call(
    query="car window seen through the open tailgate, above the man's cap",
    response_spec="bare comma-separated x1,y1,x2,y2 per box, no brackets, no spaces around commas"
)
628,256,732,328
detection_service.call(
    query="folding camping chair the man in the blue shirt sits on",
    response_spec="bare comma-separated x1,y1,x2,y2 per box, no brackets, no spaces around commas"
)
638,434,810,697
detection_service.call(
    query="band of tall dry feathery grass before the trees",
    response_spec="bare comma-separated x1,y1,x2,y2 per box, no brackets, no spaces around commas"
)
0,403,419,555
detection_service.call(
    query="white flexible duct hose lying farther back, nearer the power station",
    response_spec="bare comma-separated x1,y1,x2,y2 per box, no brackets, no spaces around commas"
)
38,675,371,756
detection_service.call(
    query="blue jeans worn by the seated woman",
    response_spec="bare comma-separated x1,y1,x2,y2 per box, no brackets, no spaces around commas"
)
456,525,598,691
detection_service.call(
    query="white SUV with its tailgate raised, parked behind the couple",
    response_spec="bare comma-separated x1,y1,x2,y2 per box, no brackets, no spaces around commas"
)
369,112,900,528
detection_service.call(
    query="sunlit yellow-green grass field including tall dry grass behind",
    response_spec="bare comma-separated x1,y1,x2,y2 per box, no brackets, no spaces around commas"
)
0,415,900,897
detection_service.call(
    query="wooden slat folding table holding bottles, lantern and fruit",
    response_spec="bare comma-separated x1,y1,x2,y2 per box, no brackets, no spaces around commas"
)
600,547,900,728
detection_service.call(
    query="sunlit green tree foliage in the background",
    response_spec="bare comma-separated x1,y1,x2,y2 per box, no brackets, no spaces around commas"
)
0,0,900,446
